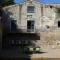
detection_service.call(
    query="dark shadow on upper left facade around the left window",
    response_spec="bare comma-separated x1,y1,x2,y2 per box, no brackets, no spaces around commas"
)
3,10,26,34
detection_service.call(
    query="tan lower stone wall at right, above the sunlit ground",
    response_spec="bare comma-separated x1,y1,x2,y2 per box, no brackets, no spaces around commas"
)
36,30,60,48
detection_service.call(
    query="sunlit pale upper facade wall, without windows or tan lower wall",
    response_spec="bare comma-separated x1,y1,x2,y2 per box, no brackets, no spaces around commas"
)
4,2,56,32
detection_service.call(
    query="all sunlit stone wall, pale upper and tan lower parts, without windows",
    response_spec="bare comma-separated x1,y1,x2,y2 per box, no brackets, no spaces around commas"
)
4,2,60,48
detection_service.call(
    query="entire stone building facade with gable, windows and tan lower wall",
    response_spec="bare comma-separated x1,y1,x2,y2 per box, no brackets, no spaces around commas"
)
3,0,60,48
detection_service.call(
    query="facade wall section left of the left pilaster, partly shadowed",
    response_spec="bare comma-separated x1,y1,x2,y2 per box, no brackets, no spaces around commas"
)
3,5,20,29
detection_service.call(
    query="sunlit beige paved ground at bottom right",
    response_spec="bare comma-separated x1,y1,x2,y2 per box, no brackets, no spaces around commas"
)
31,49,60,58
